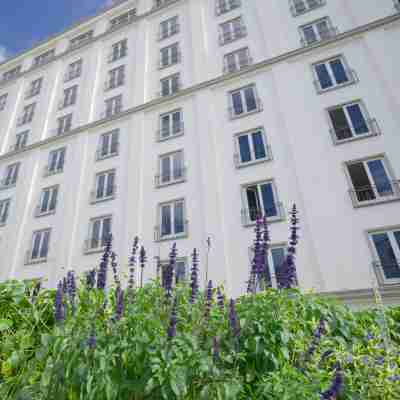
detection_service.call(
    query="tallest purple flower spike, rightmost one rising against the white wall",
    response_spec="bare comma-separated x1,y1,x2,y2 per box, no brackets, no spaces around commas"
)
276,204,300,289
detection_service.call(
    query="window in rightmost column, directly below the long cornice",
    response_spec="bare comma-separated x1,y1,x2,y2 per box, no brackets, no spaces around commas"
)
313,57,357,92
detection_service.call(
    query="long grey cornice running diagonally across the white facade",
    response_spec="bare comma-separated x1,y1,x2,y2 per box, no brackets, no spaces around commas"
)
0,12,400,161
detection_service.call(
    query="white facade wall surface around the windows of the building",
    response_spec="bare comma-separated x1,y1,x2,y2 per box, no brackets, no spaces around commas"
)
0,0,400,304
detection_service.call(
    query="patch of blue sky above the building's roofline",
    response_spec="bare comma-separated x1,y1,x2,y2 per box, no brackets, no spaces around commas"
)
0,0,111,61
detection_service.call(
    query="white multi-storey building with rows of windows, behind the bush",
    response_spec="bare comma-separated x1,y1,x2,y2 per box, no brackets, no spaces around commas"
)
0,0,400,304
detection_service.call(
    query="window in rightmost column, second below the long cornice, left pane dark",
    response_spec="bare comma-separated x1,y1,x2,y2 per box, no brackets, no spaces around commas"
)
328,101,378,143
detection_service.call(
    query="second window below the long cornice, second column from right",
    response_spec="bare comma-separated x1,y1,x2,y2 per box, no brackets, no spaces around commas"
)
235,128,270,167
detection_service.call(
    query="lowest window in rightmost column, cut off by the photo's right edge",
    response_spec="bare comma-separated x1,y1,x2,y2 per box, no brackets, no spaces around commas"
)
369,228,400,283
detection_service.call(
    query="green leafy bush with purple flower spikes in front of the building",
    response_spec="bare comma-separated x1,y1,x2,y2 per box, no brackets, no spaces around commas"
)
0,211,400,400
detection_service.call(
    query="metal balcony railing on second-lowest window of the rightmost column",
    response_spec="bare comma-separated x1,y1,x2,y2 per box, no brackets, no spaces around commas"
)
349,181,400,208
